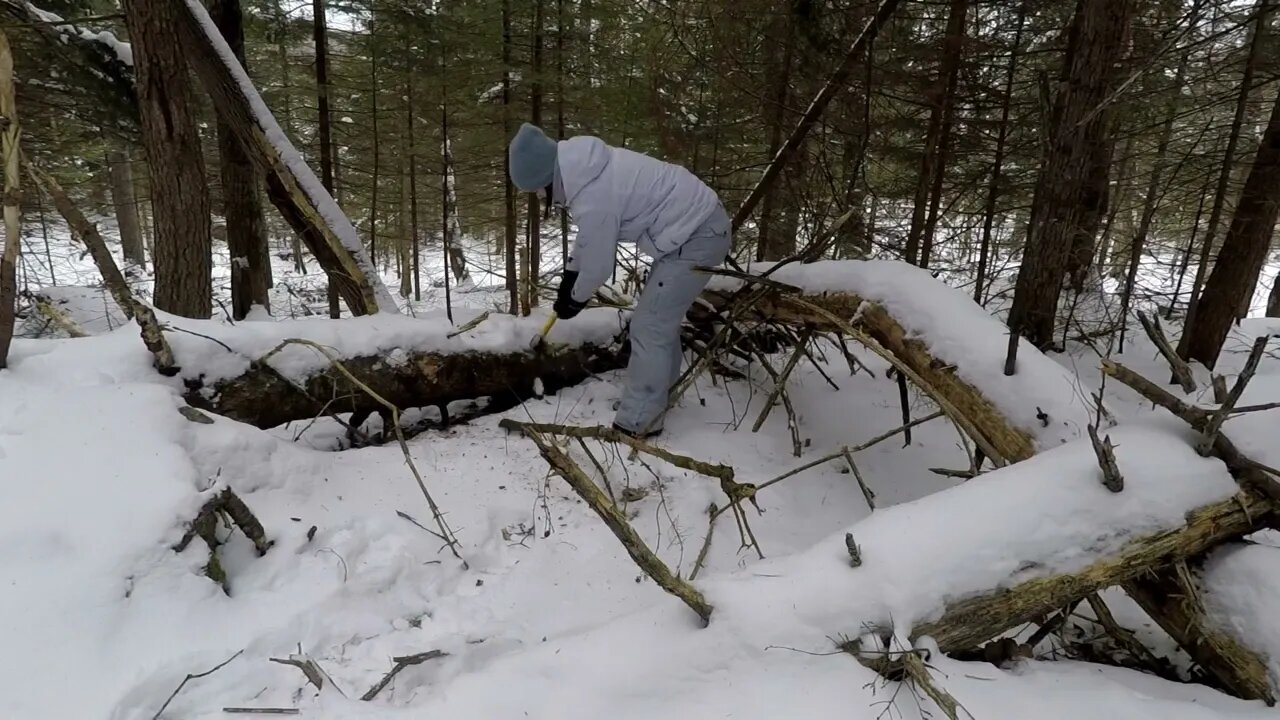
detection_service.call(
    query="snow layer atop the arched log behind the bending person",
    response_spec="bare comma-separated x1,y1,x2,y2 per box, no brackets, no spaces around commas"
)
708,260,1091,450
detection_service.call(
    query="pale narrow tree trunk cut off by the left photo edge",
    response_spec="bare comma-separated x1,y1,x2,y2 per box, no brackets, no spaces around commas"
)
0,29,22,369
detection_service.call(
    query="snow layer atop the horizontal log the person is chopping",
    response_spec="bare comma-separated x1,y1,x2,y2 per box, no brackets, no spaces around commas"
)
170,307,628,386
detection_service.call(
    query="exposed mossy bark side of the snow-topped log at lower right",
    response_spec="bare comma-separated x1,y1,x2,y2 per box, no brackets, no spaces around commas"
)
911,491,1275,652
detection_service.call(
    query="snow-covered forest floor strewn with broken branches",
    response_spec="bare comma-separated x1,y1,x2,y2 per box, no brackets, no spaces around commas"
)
0,221,1280,720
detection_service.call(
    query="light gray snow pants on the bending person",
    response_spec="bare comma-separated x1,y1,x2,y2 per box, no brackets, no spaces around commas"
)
613,208,732,432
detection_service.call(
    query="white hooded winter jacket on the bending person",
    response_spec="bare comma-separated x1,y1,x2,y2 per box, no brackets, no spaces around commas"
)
553,136,721,302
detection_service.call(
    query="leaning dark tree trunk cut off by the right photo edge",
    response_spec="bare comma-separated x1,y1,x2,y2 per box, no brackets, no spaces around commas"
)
1188,95,1280,369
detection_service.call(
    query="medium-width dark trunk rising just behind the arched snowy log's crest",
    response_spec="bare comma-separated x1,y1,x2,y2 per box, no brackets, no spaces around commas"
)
906,0,969,268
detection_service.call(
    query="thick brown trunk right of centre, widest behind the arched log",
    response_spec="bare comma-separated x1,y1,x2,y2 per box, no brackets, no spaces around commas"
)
1006,0,1133,351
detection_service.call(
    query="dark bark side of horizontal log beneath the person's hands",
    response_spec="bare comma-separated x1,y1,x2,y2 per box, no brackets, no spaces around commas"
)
186,345,626,428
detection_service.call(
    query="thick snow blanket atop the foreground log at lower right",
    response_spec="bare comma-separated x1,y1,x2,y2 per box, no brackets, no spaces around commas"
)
707,425,1239,642
